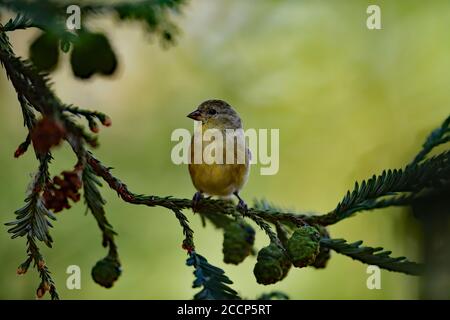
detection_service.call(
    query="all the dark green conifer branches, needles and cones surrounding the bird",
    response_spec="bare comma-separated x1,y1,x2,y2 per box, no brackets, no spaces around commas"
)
0,0,450,299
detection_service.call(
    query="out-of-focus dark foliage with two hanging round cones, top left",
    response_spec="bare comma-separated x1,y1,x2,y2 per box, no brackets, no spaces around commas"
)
0,0,184,79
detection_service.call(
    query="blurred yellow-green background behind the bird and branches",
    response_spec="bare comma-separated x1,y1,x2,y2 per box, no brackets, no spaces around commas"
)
0,0,450,299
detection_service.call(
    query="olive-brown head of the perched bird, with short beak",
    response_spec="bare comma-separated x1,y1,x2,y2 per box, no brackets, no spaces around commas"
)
187,100,242,129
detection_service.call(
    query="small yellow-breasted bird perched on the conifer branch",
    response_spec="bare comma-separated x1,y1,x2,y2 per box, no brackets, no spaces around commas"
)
188,100,250,211
